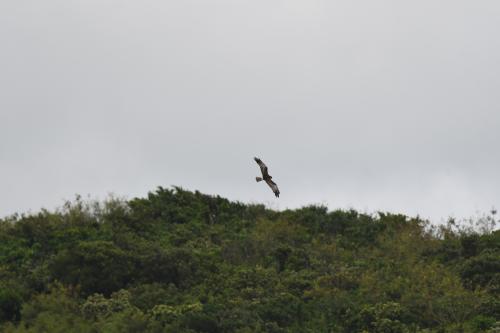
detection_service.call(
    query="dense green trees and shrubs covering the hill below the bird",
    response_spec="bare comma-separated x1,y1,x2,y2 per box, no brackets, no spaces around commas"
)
0,188,500,333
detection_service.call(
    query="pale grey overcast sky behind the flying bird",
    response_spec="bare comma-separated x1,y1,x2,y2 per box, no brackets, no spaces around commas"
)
0,0,500,222
